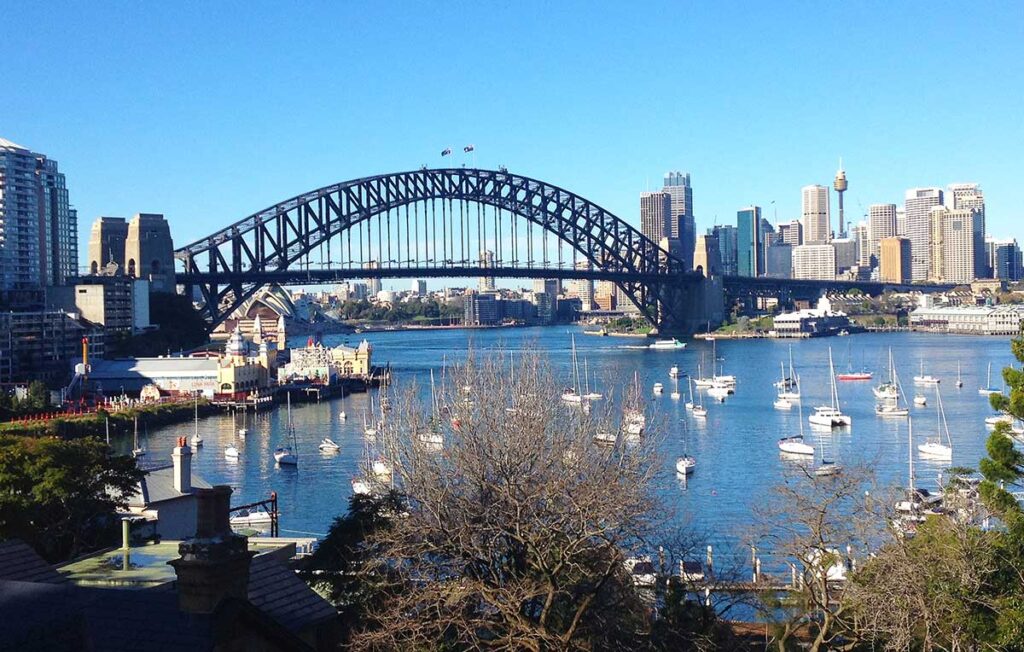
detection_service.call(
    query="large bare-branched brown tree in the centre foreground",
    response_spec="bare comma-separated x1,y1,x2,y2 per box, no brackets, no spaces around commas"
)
354,353,660,650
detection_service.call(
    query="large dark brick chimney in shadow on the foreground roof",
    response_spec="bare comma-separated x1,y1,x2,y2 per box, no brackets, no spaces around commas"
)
167,485,255,613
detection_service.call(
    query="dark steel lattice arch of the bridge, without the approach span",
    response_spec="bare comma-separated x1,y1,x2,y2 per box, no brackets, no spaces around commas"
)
175,168,701,324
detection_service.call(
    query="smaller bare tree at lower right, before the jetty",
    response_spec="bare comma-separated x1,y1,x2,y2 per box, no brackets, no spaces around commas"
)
752,464,878,652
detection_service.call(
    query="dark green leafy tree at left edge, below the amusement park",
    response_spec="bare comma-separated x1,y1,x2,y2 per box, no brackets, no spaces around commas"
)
0,435,141,562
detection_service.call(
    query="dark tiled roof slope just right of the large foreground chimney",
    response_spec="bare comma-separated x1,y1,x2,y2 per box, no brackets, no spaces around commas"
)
249,555,338,632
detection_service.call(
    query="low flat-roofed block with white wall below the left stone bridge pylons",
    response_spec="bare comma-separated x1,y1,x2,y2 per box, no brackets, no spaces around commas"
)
46,274,150,335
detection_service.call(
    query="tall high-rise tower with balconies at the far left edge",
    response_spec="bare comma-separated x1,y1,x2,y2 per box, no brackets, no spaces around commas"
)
0,138,78,291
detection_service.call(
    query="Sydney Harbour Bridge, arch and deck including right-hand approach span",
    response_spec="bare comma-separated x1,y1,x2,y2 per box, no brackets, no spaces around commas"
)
175,168,942,334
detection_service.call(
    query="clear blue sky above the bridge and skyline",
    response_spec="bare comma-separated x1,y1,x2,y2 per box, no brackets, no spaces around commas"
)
0,0,1024,270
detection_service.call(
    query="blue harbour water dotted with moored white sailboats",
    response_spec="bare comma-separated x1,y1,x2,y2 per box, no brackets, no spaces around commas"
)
128,325,1013,548
